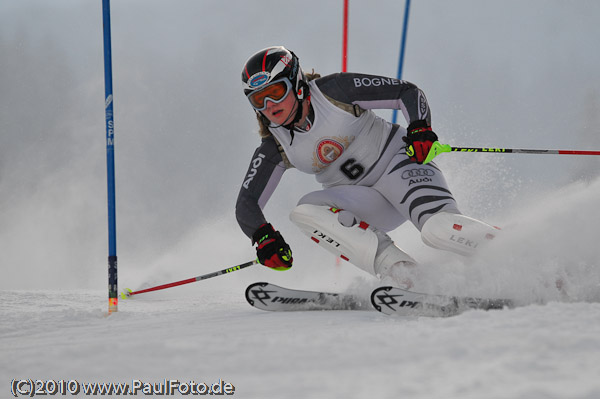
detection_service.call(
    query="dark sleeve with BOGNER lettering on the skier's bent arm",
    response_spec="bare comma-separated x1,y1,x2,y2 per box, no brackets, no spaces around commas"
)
316,73,431,125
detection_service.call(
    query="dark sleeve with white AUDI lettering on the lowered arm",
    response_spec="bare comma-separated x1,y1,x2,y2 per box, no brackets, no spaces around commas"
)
235,137,286,238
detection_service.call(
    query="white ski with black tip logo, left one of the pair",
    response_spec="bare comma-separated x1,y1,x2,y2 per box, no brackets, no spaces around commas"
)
246,282,371,312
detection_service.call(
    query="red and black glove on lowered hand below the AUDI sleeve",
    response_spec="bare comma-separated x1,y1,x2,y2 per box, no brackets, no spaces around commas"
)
252,223,294,270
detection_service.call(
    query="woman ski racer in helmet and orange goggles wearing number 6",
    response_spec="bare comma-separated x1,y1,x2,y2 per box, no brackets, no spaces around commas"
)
236,46,496,286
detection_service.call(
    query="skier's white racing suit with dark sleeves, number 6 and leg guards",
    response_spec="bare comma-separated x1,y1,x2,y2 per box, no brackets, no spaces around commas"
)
236,73,494,275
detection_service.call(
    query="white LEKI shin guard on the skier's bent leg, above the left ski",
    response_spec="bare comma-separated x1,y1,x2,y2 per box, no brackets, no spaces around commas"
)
290,204,378,275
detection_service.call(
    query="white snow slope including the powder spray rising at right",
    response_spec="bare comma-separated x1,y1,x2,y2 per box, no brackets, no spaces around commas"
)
0,180,600,399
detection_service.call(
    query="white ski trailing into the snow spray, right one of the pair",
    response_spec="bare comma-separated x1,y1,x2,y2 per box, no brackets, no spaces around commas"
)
371,287,514,317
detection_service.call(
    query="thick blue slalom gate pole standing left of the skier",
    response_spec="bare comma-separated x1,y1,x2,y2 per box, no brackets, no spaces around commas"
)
102,0,119,314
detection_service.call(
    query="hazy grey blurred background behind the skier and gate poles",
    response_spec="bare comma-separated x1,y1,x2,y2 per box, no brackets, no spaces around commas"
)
0,0,600,292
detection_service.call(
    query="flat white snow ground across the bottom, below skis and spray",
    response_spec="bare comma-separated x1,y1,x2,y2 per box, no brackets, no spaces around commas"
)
0,291,600,399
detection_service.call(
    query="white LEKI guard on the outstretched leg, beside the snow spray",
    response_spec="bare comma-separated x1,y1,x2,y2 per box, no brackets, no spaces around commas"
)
421,212,499,256
